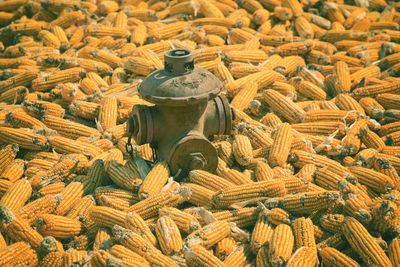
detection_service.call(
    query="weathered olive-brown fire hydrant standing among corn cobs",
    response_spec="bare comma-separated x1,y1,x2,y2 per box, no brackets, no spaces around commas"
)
128,49,234,177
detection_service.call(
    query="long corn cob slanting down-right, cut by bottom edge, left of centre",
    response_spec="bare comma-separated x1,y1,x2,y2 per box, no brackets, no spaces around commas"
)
112,225,178,266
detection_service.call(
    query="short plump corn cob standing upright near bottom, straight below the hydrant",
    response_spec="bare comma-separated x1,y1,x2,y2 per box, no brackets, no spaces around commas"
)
156,215,183,255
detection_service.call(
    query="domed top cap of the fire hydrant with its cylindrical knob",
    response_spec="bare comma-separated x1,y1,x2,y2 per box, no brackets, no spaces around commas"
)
138,49,222,106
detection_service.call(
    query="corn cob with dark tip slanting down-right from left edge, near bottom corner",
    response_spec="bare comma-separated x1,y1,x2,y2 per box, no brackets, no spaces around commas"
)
0,206,43,249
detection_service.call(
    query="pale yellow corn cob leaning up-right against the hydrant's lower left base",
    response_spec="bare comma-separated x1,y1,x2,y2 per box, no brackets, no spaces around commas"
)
139,162,169,199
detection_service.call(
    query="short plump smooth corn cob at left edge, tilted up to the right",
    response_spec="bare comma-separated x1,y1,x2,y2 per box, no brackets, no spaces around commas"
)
0,179,32,212
